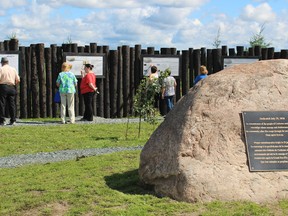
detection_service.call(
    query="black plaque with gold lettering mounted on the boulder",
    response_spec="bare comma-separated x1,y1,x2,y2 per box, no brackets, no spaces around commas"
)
242,111,288,171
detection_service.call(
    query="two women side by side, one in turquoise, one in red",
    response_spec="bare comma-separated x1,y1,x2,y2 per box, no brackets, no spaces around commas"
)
56,62,97,124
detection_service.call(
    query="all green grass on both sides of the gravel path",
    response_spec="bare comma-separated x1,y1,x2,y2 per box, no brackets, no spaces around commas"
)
0,120,288,216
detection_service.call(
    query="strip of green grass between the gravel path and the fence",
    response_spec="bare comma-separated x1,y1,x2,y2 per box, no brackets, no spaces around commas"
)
0,122,156,157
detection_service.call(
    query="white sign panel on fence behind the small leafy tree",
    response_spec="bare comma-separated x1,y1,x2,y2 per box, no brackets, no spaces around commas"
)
142,55,180,77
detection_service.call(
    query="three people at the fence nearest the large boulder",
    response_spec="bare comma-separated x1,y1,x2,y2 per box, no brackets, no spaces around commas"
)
149,65,208,113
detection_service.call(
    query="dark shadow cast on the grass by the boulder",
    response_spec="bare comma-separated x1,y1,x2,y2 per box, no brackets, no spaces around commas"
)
104,169,156,196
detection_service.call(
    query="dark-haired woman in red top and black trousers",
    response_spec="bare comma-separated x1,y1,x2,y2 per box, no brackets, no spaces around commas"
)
80,64,98,121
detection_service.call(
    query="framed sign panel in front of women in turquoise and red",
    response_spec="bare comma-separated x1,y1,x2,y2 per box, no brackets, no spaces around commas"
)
64,53,105,78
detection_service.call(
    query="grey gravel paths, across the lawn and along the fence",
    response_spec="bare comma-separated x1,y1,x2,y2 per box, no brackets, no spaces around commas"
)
0,117,158,168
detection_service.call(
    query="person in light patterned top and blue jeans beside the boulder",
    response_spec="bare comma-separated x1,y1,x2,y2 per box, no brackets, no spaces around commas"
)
162,70,177,113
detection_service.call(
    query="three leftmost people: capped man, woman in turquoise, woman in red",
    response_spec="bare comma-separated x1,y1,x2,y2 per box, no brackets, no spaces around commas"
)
0,57,98,126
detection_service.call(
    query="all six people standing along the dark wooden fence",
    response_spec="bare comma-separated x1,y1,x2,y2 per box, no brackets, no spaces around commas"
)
0,57,208,126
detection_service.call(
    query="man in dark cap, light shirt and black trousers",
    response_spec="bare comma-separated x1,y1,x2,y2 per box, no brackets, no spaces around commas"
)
0,57,20,126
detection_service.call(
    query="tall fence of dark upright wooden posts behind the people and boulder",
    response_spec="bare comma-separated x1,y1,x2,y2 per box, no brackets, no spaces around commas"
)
0,39,288,118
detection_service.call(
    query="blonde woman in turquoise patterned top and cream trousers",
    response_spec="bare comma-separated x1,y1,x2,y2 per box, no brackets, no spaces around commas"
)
56,62,77,124
